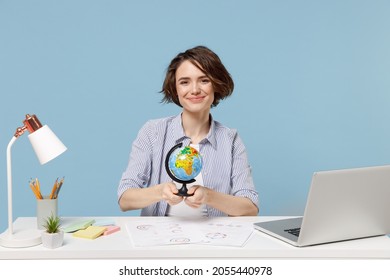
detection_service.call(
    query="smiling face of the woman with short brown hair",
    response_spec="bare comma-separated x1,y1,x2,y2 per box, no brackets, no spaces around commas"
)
176,60,214,113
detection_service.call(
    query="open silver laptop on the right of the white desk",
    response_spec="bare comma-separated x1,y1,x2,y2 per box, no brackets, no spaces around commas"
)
254,165,390,247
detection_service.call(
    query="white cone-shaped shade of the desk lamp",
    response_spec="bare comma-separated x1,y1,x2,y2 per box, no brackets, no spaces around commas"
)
28,125,66,164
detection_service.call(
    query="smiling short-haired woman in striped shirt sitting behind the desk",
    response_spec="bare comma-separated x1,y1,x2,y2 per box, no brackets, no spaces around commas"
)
118,46,258,217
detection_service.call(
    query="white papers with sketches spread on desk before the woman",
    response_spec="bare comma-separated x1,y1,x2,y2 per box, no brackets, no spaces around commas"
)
126,218,253,247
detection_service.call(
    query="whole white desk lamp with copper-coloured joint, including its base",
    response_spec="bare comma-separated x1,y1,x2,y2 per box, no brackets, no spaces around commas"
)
0,115,66,248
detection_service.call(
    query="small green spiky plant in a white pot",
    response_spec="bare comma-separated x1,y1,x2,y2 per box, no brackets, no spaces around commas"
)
42,215,64,249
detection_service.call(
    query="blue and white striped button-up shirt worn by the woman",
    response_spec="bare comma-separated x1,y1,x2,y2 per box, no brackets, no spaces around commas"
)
118,114,258,217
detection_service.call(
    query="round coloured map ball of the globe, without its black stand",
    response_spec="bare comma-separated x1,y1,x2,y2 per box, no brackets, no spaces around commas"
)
168,146,202,181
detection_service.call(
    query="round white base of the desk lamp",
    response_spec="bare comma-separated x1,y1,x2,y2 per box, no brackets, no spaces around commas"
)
0,229,42,248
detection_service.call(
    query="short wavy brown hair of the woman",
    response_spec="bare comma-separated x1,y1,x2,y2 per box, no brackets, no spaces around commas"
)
161,46,234,107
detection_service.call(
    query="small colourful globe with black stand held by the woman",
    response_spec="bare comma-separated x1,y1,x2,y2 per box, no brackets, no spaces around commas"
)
165,143,202,196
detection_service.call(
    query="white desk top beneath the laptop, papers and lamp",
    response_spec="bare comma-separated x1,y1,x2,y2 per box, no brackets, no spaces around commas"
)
0,216,390,259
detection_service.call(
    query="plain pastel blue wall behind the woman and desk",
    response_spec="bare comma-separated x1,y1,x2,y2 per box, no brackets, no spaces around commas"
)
0,0,390,231
